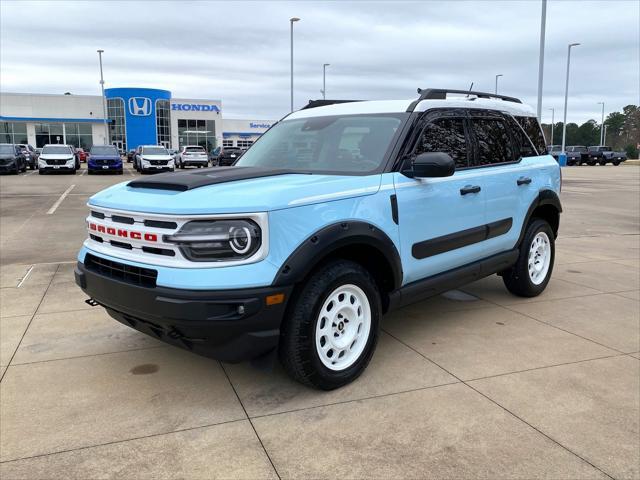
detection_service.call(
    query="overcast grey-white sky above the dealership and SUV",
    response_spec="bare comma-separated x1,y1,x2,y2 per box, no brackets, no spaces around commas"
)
0,0,640,123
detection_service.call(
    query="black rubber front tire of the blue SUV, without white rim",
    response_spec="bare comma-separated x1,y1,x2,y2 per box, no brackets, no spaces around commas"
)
278,260,382,390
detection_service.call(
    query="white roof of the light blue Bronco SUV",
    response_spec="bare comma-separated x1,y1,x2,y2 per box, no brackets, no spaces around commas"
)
287,92,535,120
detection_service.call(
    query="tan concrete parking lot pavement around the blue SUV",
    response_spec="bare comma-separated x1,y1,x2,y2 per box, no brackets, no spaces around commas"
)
0,166,640,479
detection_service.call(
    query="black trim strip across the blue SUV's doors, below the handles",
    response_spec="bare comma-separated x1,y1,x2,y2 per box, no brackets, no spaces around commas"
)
411,218,513,260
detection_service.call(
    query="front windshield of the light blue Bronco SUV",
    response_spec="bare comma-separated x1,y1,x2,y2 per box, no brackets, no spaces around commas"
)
236,114,406,174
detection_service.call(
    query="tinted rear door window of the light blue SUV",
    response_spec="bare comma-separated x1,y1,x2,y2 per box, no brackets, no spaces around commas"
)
471,118,518,166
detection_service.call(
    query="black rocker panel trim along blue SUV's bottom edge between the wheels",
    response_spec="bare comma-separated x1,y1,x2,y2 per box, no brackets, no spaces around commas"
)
389,248,519,311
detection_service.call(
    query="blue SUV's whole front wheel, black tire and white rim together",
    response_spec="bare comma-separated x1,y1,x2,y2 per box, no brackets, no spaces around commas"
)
278,260,382,390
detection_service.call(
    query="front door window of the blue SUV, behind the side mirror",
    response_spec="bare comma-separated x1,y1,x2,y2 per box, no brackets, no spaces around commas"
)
416,118,469,168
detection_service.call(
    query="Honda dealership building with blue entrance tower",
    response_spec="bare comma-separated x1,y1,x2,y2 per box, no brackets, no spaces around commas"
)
0,88,274,151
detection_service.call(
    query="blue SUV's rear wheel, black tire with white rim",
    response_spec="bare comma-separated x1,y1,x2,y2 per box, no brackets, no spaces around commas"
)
502,218,555,297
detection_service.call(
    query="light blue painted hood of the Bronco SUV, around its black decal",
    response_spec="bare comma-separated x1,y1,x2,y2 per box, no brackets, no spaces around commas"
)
89,173,381,215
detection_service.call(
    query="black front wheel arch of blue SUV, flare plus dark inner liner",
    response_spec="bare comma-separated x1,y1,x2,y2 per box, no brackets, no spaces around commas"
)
272,221,402,311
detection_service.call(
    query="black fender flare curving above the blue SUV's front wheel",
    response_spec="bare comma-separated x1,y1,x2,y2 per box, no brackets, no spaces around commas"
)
272,221,402,288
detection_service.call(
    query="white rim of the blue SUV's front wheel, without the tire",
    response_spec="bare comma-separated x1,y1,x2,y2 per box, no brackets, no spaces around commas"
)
315,284,371,371
